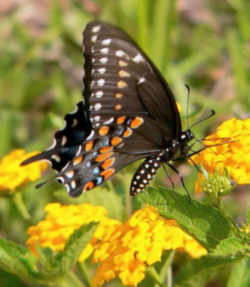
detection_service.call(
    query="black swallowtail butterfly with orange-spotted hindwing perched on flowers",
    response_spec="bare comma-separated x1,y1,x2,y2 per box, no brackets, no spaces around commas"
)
23,21,194,196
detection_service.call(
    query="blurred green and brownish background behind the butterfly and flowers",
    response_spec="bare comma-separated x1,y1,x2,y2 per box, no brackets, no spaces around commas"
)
0,0,250,286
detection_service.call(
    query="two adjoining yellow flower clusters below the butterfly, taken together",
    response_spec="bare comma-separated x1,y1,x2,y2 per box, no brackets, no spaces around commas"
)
27,203,207,286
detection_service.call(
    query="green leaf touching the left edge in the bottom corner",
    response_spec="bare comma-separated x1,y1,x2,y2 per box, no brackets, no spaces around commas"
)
0,238,36,279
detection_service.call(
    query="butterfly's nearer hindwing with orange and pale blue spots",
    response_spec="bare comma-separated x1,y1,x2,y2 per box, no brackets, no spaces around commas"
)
54,116,150,196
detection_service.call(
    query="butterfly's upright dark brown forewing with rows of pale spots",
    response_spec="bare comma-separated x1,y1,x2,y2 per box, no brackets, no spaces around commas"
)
83,21,181,141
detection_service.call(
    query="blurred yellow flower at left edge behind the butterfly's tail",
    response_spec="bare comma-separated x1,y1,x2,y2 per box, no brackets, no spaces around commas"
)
0,149,47,192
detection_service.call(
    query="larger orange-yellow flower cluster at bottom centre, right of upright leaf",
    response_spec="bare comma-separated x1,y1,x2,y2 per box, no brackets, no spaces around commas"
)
92,206,207,287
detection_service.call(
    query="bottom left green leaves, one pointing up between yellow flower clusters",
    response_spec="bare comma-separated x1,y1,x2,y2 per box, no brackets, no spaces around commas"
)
0,223,96,287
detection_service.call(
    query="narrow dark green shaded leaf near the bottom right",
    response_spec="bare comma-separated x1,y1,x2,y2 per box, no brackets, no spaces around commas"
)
175,256,239,286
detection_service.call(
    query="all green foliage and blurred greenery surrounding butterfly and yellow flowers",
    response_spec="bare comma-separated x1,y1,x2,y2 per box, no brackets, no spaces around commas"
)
0,0,250,287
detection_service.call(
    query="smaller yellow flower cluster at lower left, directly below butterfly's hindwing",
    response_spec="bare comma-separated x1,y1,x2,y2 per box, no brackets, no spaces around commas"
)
26,203,107,257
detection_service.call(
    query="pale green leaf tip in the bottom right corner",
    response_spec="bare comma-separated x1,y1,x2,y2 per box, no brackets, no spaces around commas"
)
227,258,250,287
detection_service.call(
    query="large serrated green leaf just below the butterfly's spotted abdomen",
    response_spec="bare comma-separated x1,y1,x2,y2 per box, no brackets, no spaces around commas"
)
139,187,235,251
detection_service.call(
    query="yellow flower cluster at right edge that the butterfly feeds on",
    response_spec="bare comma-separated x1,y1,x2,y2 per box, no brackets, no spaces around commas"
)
192,119,250,186
